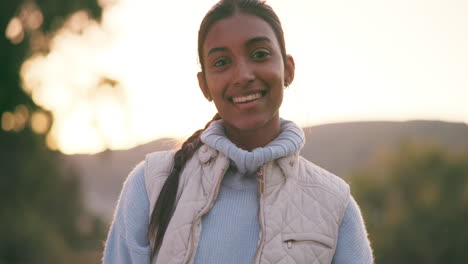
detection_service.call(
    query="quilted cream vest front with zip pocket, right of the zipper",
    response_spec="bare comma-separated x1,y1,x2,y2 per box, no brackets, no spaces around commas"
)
261,158,349,264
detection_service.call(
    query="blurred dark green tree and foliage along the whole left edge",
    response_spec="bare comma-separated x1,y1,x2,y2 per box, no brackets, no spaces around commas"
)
0,0,104,264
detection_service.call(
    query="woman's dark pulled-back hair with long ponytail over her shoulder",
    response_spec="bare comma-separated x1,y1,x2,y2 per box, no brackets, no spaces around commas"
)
148,0,286,257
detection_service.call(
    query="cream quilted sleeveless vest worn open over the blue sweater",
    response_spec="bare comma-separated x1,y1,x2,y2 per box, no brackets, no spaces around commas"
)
145,145,350,264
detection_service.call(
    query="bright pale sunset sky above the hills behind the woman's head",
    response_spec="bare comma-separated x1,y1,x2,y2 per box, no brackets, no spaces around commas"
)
16,0,468,154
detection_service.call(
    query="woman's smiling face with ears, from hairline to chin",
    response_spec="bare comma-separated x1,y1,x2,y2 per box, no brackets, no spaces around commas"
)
198,13,294,132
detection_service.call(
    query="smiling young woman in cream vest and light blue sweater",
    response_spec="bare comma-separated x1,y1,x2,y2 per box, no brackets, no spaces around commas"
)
104,0,373,264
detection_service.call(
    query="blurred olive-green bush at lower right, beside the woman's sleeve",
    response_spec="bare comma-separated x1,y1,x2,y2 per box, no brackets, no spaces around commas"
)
351,142,468,264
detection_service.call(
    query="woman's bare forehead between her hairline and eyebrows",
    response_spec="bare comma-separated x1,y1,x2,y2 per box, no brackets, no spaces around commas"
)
203,13,279,55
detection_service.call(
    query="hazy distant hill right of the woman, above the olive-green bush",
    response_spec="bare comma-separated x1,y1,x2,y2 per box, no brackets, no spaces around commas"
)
301,121,468,178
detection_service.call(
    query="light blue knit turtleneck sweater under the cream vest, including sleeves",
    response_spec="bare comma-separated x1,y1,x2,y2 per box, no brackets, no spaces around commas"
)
104,120,372,264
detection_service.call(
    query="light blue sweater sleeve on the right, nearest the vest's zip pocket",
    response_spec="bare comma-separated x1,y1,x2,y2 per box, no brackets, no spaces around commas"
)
332,197,373,264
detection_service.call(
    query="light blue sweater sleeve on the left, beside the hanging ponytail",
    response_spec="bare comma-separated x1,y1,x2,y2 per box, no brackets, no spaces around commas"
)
103,162,151,264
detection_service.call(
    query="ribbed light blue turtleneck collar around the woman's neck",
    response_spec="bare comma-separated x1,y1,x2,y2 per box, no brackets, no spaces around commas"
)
200,119,305,174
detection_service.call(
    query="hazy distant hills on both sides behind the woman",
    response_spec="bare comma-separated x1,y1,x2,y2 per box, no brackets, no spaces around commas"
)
63,121,468,220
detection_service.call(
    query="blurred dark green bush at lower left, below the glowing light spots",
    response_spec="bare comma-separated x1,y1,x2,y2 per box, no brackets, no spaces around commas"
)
0,126,105,264
